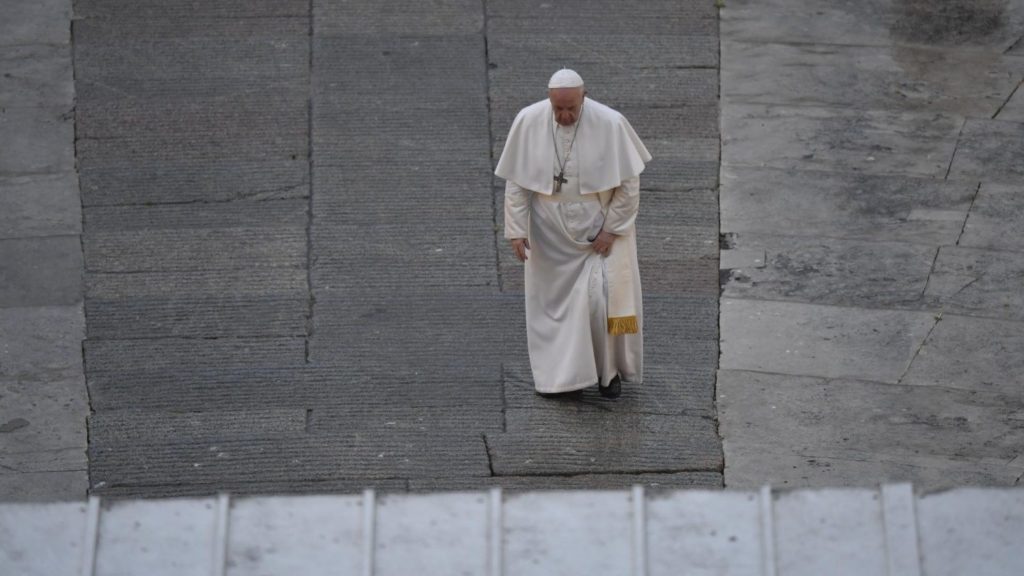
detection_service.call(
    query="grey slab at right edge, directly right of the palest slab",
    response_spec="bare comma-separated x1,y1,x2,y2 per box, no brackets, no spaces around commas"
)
902,314,1024,399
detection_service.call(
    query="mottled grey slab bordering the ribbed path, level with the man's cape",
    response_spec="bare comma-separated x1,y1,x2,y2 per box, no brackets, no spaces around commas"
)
722,105,963,177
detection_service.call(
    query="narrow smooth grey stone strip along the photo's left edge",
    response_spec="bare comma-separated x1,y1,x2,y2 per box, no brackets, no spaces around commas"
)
0,0,88,501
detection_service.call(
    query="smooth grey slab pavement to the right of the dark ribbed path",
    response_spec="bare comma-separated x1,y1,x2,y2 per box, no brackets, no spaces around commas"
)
717,0,1024,489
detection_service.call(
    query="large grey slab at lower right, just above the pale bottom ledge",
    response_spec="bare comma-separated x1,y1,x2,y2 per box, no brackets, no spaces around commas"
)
718,370,1024,489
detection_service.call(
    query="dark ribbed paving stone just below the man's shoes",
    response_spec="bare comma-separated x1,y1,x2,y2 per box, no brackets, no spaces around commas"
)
486,409,722,476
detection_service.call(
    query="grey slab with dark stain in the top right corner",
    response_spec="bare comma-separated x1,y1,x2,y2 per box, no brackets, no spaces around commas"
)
721,0,1024,52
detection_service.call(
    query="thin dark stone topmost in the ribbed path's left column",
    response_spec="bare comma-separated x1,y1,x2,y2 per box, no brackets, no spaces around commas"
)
75,0,309,18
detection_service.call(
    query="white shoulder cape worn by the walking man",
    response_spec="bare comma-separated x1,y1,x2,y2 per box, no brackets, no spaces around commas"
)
495,98,650,195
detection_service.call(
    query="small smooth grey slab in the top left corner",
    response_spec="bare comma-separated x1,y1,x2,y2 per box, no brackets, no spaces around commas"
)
0,0,72,46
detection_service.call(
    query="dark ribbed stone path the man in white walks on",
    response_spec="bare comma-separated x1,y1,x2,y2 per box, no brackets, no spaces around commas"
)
0,0,723,499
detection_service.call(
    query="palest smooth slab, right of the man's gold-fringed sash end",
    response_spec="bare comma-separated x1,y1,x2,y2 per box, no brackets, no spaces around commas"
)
720,298,935,383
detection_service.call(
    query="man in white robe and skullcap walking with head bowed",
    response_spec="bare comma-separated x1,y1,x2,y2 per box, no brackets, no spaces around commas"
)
495,70,650,398
